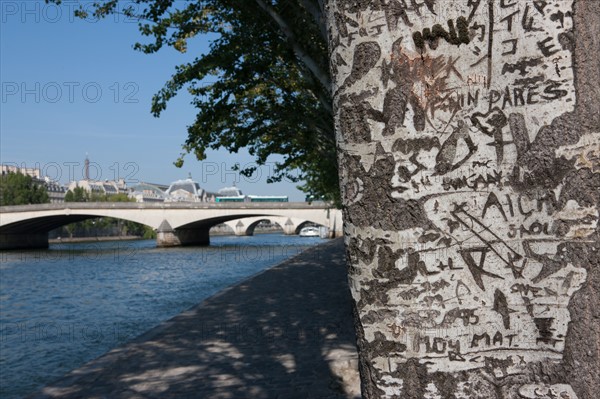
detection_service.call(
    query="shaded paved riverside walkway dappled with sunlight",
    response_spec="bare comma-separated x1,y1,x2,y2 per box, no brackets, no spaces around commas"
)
32,239,360,399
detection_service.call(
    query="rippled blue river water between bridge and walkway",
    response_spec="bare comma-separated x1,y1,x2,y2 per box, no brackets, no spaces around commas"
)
0,234,323,399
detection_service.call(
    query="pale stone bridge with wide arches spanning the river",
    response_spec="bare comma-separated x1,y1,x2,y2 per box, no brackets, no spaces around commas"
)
0,202,342,249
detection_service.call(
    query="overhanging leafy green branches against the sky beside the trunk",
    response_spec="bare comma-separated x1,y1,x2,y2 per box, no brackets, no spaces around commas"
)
50,0,339,203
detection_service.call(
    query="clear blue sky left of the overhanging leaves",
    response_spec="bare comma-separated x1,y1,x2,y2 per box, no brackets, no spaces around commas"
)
0,0,304,201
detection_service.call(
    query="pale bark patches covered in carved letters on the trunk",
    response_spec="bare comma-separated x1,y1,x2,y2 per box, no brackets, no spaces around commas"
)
331,0,600,398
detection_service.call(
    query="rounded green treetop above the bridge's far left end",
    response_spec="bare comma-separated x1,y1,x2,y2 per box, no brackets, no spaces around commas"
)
0,173,50,206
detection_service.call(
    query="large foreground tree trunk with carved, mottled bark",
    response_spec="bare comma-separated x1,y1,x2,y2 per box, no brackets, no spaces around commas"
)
326,0,600,399
